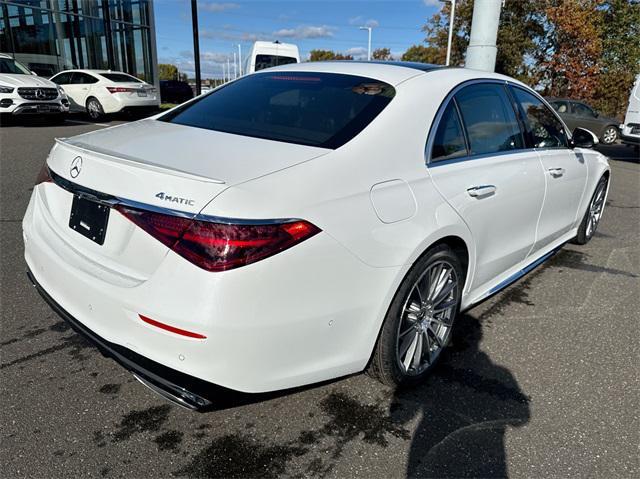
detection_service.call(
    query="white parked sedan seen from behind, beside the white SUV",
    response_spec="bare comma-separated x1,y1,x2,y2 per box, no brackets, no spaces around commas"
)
51,70,160,120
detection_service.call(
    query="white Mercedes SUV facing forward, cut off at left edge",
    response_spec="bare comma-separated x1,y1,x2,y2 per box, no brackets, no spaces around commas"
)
0,53,69,122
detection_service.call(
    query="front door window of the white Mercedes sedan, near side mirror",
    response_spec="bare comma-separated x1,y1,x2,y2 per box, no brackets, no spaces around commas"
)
511,87,567,148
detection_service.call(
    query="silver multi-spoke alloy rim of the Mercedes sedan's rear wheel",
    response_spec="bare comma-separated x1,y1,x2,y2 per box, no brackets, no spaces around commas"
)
396,260,459,376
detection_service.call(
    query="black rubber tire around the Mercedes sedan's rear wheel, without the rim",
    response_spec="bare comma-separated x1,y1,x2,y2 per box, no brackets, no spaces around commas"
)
367,245,465,387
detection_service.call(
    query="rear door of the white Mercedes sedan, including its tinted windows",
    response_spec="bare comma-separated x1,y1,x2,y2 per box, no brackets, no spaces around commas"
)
427,82,544,289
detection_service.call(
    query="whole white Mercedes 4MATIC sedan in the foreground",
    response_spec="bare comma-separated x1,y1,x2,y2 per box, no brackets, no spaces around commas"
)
23,62,611,408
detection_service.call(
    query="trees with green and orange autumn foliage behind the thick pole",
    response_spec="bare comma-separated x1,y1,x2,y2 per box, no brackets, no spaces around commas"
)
310,0,640,115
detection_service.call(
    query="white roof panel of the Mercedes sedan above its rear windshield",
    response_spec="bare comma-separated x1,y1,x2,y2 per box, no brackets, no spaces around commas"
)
256,60,522,86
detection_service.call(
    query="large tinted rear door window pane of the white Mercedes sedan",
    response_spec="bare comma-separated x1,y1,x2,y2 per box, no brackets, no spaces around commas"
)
455,83,524,155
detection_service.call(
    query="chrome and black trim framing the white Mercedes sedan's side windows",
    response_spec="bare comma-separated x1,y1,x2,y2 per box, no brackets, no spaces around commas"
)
424,78,571,168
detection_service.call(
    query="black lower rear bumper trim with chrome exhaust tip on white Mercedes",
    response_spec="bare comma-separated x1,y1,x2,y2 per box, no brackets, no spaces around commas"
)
27,270,220,410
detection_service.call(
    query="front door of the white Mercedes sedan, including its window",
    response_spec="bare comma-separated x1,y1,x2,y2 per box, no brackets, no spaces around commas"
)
510,86,587,254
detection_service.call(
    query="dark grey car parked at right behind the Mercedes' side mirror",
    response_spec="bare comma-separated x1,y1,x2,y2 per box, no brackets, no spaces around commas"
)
547,98,620,145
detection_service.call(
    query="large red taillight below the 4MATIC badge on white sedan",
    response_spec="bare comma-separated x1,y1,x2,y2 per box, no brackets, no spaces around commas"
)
116,206,320,271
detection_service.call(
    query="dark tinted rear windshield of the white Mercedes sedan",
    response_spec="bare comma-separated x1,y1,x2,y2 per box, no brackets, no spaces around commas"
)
160,72,395,149
